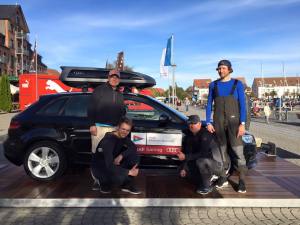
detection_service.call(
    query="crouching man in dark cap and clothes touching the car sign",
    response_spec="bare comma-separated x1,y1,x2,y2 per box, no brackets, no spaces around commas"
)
177,115,228,194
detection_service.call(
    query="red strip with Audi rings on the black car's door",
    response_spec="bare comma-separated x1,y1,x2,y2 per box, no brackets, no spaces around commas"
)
137,145,181,155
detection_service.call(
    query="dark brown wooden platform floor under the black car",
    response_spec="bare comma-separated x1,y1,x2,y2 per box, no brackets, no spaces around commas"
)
0,153,300,199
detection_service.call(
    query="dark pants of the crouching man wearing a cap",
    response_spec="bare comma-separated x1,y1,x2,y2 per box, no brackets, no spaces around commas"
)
187,158,223,188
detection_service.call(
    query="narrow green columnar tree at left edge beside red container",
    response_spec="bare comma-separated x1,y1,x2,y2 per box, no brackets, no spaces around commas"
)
0,75,12,112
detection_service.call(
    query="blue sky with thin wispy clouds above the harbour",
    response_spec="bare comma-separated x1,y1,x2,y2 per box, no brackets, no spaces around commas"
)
0,0,300,88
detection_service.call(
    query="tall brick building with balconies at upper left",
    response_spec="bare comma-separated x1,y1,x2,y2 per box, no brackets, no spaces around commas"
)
0,5,47,77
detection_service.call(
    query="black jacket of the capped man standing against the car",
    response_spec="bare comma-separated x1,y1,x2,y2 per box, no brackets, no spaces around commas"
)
88,83,126,126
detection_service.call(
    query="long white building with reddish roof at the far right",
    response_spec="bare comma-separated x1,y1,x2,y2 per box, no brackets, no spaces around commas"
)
252,77,300,99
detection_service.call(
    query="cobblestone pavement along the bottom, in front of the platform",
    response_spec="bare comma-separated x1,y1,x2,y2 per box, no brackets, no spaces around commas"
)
0,207,300,225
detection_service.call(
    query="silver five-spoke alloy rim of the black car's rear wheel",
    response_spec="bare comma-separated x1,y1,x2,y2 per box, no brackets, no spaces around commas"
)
27,147,59,178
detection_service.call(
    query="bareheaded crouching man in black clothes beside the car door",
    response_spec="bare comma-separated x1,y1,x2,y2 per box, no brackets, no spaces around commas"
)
91,118,141,194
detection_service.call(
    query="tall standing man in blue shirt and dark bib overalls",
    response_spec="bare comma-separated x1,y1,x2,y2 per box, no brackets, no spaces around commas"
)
206,60,248,193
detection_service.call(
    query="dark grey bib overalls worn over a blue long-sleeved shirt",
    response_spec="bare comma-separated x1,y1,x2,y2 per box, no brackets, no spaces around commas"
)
213,80,247,172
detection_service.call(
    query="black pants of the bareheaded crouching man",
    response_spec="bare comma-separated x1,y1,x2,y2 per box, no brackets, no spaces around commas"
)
91,154,139,186
